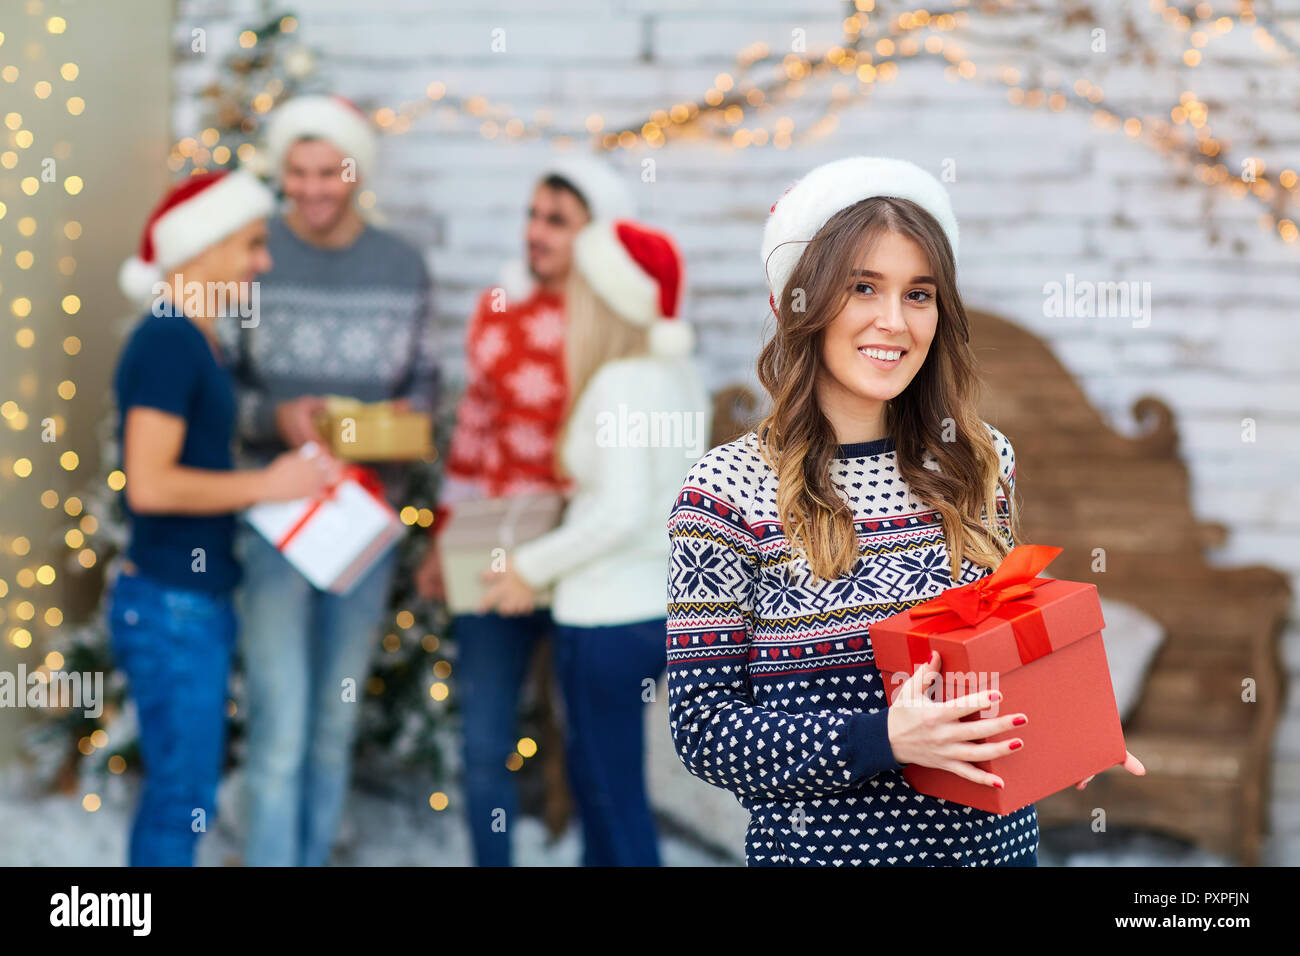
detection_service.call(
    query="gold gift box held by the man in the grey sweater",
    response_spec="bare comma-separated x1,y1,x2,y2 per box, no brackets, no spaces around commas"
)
316,395,434,462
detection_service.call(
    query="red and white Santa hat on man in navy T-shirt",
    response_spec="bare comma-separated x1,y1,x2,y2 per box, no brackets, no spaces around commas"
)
117,170,276,302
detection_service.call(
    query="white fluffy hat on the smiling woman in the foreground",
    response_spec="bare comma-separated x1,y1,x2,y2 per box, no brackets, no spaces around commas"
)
763,156,957,312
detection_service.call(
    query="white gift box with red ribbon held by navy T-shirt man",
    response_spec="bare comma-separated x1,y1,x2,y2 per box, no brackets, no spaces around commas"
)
246,468,406,594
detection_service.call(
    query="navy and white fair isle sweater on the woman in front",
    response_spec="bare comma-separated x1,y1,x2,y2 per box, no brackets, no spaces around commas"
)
667,423,1039,866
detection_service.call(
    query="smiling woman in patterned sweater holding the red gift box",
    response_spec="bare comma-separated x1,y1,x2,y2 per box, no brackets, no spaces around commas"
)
668,157,1037,866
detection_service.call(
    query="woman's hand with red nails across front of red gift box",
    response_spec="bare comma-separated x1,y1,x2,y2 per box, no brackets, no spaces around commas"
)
888,650,1028,787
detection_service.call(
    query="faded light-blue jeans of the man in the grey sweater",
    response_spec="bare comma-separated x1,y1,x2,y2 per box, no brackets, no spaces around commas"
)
238,528,397,866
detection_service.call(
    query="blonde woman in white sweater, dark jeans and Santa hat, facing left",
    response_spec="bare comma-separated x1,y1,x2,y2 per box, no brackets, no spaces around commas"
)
486,220,711,866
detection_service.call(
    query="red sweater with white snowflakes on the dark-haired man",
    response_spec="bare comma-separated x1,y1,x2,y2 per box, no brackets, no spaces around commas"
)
438,287,569,515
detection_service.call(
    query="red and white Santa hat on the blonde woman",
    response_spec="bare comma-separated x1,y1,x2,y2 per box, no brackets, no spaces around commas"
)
573,219,694,358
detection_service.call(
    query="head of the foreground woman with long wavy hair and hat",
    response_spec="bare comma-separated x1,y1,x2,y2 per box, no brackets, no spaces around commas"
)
758,166,1002,590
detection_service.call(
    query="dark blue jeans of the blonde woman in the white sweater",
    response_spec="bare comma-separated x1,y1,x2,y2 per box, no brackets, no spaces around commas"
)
555,618,668,866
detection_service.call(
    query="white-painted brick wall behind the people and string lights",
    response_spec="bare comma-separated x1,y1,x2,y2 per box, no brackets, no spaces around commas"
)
174,0,1300,864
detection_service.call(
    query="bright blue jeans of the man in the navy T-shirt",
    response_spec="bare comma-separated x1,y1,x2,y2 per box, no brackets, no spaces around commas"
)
108,570,237,866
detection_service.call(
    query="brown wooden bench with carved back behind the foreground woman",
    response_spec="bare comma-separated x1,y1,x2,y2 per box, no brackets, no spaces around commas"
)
970,312,1291,865
